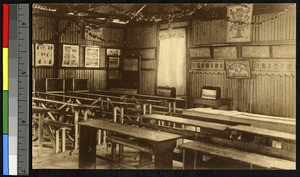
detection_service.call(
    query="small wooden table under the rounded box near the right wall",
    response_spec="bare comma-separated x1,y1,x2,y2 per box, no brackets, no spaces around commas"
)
193,98,232,110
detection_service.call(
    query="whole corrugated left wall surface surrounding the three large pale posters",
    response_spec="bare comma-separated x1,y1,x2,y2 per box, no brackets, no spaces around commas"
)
32,14,124,89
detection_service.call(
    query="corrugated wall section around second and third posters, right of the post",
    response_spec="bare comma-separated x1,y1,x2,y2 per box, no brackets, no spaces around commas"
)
58,20,124,90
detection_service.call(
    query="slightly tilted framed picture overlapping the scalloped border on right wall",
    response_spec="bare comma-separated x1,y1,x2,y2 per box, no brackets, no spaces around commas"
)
225,60,251,79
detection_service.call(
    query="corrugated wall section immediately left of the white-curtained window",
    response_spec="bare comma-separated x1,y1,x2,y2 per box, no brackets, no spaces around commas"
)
125,26,157,95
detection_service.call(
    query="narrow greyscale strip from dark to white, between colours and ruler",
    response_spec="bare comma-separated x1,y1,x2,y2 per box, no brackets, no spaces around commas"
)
8,4,18,175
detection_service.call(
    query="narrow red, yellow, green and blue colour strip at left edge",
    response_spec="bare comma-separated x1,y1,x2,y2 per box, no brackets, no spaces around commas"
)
2,4,9,175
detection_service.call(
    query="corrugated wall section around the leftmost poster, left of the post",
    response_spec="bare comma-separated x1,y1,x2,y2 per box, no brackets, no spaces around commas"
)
32,16,57,83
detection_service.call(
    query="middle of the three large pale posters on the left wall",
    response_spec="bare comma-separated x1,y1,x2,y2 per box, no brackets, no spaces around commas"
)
62,45,79,67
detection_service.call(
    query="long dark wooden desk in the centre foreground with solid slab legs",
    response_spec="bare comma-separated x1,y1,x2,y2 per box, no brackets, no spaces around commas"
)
78,120,181,169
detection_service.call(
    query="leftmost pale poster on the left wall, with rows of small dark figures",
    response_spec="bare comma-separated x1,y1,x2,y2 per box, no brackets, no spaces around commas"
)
34,43,54,66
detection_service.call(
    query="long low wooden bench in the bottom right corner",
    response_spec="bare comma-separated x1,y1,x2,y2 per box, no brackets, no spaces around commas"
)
178,141,296,170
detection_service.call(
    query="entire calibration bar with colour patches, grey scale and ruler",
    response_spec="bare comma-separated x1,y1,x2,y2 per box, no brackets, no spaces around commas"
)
1,4,30,175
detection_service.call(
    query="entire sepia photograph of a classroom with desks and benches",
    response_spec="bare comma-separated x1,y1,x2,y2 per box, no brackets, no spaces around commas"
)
31,3,296,170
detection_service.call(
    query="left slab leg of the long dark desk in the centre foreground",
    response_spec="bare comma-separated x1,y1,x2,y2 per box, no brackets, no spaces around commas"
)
79,126,97,169
